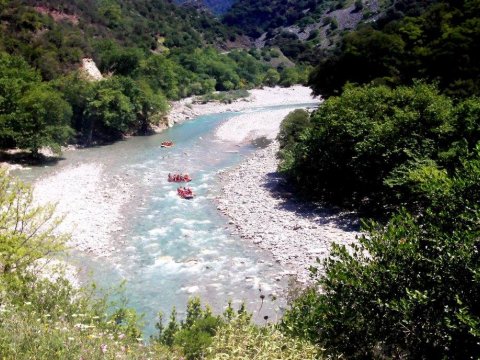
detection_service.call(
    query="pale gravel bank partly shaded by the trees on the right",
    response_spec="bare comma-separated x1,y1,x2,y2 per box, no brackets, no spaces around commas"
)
217,142,359,284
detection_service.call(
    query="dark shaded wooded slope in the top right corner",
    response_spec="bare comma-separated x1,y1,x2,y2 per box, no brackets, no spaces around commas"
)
310,1,480,98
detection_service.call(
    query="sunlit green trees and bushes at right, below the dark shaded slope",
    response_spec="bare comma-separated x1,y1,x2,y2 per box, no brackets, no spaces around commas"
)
280,71,480,359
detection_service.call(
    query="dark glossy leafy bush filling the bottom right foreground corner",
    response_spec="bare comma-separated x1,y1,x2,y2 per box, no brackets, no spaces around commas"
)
283,166,480,359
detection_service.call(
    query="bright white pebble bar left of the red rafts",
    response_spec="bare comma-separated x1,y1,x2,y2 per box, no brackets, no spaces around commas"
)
34,163,132,256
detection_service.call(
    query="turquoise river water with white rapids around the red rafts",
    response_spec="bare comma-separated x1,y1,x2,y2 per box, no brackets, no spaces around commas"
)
21,104,316,334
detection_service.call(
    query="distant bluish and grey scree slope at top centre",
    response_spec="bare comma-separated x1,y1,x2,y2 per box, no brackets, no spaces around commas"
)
222,0,440,64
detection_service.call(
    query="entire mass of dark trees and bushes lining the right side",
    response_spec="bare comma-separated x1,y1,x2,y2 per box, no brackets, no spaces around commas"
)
279,1,480,359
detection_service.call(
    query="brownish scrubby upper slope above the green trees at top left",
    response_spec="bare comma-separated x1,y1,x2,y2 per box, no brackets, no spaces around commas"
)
0,0,232,79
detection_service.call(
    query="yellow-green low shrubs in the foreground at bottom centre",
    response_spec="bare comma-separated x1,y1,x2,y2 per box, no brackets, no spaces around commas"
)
154,298,320,360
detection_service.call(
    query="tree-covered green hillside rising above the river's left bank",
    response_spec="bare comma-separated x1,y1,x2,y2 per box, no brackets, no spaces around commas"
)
0,1,308,155
